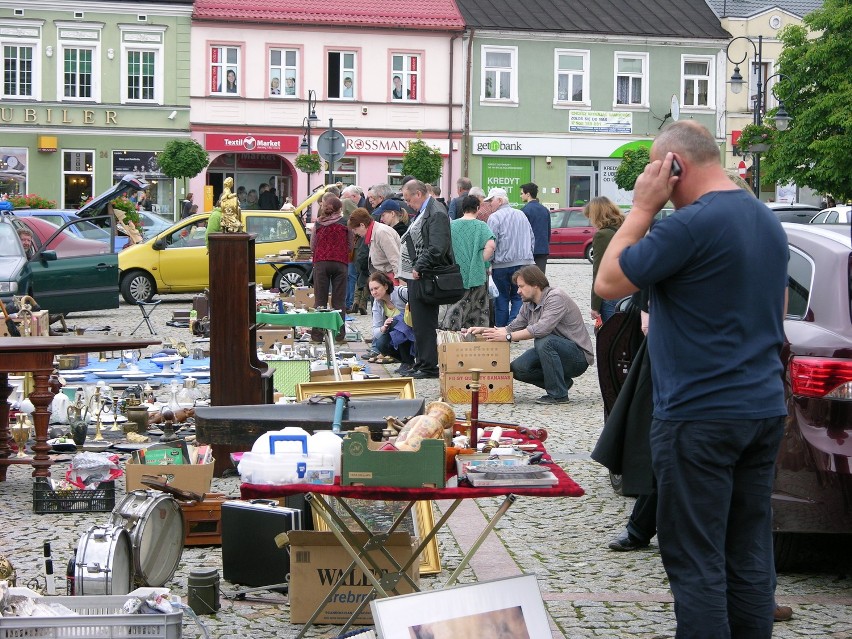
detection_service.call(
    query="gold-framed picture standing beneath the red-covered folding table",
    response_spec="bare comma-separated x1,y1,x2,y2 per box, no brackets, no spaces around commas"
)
313,498,441,575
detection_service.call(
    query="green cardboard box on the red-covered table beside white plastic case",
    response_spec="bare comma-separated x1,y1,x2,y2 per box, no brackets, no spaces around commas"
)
340,433,447,488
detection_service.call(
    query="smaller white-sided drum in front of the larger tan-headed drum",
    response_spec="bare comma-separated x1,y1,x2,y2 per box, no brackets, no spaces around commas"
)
74,526,133,595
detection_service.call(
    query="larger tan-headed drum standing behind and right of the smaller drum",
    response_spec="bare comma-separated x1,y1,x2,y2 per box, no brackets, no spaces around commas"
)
109,490,184,587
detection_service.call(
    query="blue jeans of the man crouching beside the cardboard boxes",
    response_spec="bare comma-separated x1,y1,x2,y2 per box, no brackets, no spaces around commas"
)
510,332,589,399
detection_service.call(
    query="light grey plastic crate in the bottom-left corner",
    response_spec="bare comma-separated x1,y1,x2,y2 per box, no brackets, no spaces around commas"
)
0,595,183,639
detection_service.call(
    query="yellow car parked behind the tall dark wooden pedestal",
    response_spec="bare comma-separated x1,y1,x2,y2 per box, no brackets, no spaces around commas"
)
118,211,311,304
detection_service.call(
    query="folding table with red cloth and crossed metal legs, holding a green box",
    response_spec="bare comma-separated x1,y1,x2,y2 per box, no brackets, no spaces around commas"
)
240,442,584,639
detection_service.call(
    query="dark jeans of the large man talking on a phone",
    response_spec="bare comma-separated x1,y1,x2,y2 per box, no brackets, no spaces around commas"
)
651,417,785,639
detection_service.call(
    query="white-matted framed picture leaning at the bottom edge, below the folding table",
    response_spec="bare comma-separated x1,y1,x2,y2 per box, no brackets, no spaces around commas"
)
370,575,552,639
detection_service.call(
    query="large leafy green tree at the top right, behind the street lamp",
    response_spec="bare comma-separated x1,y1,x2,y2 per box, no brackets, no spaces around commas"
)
761,0,852,201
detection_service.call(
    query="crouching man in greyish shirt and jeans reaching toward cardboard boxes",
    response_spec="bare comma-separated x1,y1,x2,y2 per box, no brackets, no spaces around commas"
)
465,265,595,404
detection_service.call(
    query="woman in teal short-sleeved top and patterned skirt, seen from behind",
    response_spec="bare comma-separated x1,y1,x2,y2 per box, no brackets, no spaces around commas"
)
436,195,497,331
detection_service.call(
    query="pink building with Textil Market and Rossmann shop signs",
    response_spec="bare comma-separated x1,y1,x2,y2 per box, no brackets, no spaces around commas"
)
190,0,464,208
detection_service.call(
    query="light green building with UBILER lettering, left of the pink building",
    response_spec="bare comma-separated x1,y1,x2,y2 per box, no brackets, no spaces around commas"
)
0,0,192,216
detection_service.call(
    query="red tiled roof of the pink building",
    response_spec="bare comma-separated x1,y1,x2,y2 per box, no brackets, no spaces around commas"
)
193,0,464,31
